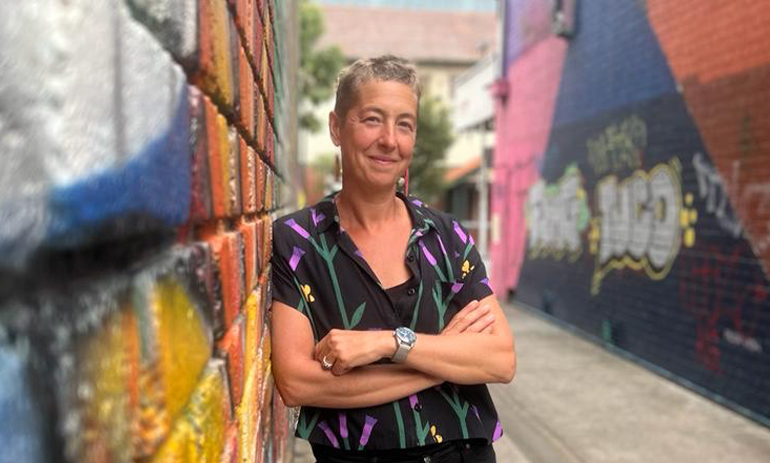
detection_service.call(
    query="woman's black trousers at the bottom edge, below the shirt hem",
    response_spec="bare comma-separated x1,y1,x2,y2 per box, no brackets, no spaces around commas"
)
313,441,497,463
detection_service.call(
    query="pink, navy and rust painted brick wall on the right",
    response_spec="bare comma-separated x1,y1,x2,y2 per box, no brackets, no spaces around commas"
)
490,0,770,424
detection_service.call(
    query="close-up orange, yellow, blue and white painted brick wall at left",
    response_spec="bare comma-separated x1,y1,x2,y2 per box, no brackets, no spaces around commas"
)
0,0,296,463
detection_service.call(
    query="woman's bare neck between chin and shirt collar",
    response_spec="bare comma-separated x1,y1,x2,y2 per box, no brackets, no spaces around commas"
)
337,187,401,231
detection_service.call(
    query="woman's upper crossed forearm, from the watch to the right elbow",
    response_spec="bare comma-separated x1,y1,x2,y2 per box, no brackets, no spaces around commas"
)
404,333,516,384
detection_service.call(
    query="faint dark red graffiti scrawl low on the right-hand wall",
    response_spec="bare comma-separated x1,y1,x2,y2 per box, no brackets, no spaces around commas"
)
679,242,768,373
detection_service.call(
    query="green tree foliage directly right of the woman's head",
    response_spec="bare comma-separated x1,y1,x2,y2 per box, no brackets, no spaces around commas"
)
409,96,453,202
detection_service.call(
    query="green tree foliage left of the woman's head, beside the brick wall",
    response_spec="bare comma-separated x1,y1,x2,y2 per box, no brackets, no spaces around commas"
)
299,0,345,132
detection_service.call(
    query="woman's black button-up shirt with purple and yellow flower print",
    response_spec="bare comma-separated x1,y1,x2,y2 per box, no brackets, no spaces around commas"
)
272,190,502,450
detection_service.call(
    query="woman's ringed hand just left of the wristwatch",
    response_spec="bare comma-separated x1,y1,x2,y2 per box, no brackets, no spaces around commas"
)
314,329,396,376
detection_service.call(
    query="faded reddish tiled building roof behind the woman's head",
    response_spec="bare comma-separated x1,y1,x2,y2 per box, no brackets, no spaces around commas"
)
318,5,497,63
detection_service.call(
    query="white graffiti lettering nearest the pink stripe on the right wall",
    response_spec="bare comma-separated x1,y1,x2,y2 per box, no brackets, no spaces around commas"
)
526,165,590,262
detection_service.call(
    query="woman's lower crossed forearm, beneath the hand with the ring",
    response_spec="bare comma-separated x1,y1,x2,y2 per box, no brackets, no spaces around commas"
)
276,362,443,408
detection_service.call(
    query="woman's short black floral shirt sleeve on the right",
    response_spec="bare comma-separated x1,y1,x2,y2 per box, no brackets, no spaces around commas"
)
449,220,494,307
